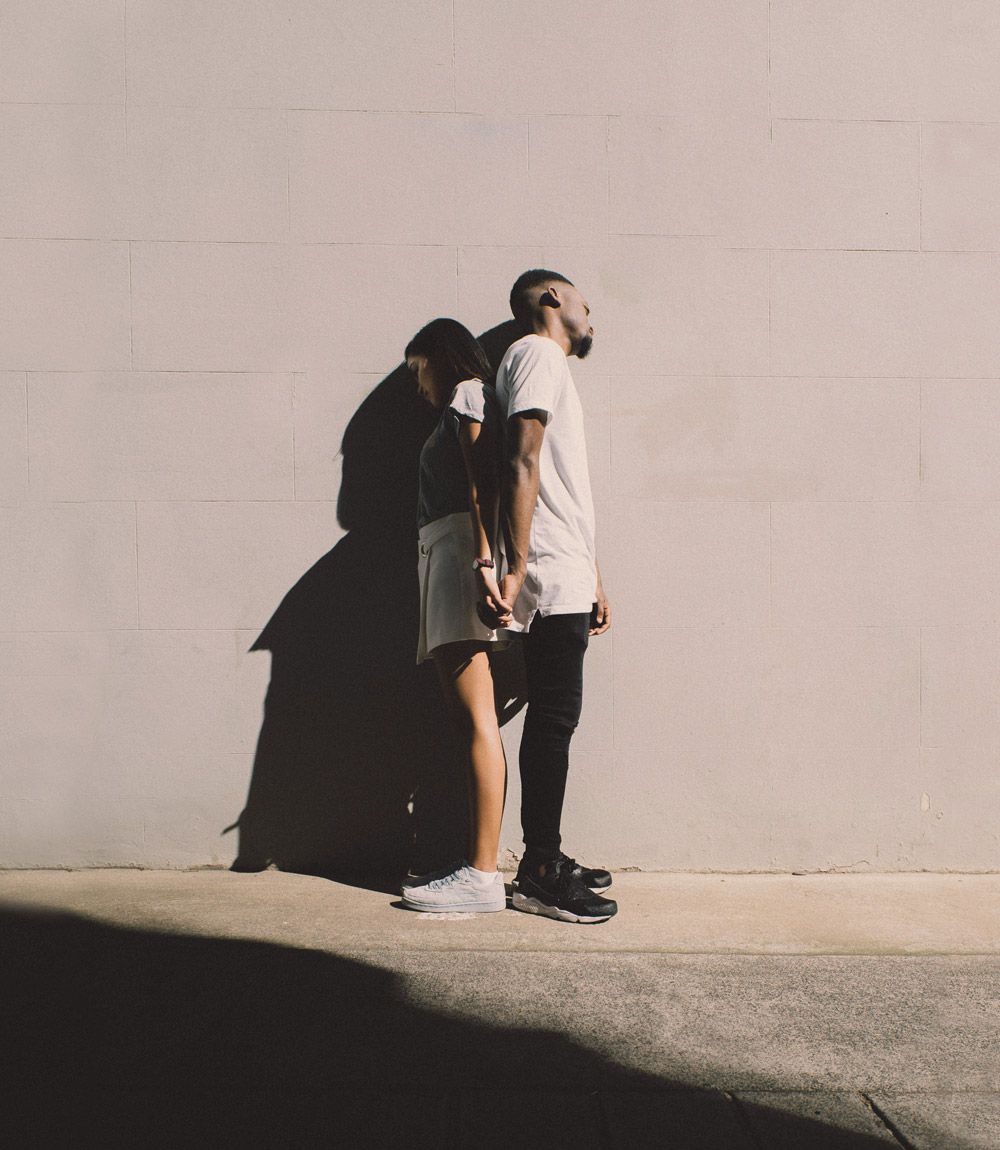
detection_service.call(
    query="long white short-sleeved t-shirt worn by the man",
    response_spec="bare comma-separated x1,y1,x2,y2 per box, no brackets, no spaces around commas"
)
497,335,598,630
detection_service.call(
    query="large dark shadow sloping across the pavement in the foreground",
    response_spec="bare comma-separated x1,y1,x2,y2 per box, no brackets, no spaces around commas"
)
0,909,910,1150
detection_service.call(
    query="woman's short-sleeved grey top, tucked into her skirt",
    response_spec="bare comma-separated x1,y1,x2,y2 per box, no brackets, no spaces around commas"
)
417,380,503,529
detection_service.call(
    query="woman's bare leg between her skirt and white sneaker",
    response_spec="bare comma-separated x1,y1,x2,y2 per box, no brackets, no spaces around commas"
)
431,642,507,871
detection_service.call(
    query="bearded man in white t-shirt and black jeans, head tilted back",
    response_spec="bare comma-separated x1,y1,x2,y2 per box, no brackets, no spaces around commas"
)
483,269,618,922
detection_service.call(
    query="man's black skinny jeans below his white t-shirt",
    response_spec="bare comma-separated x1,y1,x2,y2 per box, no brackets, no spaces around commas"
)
518,613,591,856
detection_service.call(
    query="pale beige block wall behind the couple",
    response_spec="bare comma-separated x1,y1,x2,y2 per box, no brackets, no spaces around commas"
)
0,0,1000,871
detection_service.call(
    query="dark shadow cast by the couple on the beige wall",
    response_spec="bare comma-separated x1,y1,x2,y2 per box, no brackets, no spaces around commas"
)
228,323,523,883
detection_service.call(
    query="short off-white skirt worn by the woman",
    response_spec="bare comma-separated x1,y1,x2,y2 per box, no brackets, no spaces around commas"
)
417,511,510,662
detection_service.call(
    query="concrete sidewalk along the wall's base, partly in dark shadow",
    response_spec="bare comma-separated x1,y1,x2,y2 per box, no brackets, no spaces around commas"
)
0,871,1000,1150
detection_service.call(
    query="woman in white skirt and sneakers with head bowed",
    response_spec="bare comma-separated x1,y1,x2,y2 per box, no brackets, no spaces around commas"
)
402,320,510,913
